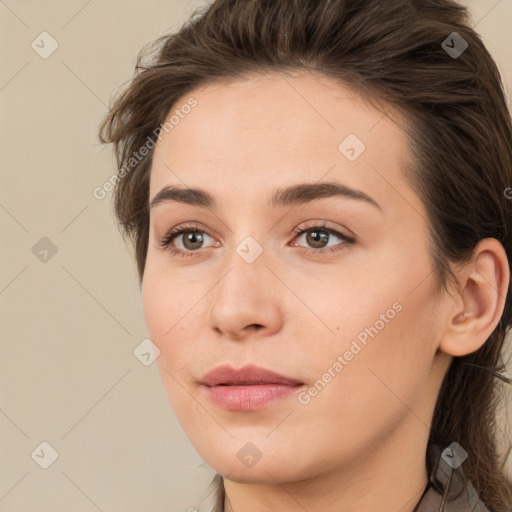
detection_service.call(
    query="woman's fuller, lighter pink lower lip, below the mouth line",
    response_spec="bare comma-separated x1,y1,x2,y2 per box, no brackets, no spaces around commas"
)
204,384,302,411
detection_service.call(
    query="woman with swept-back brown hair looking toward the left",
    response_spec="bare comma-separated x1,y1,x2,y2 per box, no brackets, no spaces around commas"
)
100,0,512,512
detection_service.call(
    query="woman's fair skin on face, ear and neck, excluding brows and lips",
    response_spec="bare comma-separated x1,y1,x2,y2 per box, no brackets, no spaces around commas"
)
142,73,509,512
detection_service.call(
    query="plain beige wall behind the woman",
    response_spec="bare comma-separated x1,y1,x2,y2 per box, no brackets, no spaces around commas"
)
0,0,512,512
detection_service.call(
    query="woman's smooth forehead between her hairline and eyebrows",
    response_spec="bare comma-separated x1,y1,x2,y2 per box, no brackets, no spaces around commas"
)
150,69,412,216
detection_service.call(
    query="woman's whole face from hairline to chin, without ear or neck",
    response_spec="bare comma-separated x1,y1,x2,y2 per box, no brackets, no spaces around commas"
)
143,74,447,483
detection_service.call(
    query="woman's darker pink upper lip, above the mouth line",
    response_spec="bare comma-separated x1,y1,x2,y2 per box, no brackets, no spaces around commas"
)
200,364,303,386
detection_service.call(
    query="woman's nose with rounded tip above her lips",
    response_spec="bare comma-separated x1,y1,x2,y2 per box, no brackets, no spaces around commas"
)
209,247,284,341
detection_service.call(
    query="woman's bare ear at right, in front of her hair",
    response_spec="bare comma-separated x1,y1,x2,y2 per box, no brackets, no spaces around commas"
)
439,238,510,356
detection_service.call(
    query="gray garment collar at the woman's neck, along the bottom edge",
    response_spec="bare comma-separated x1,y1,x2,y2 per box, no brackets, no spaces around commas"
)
198,444,490,512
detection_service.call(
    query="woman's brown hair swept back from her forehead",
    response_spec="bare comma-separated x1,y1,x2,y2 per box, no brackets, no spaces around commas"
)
100,0,512,512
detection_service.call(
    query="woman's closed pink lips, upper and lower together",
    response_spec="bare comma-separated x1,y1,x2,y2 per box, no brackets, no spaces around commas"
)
200,365,304,411
